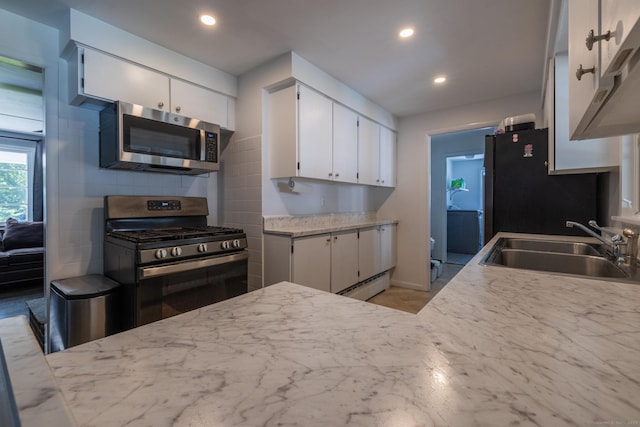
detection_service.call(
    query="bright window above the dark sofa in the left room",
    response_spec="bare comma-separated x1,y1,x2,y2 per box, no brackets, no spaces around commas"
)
0,138,36,224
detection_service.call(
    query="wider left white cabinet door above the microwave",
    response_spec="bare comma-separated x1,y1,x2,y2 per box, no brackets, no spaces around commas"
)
83,48,169,110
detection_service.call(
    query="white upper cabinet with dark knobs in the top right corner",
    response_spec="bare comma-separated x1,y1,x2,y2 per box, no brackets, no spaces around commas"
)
568,0,640,139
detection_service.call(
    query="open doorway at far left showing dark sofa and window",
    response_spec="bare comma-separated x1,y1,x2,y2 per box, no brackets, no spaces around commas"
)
0,56,46,340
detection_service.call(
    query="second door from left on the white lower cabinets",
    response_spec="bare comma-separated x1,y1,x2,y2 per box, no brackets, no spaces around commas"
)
331,231,358,293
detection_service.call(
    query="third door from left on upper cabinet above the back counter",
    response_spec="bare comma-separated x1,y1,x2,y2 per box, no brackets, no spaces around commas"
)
358,117,380,185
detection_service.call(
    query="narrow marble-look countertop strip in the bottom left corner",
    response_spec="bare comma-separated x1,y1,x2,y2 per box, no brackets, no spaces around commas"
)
0,316,76,427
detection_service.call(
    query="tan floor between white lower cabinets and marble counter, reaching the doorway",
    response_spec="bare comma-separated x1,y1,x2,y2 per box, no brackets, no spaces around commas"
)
367,263,464,314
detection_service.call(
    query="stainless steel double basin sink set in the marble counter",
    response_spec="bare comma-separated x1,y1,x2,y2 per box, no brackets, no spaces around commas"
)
481,237,640,283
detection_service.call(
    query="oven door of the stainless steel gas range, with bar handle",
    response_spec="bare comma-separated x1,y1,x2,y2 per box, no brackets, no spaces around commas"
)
135,251,249,326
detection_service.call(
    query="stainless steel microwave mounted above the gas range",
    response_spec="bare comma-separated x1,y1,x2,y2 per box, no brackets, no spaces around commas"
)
100,101,220,175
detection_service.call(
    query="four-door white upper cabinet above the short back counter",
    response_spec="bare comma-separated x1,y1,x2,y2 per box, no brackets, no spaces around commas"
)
268,84,396,186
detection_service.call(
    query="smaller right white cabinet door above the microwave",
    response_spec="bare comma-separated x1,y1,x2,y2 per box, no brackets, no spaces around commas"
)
171,79,228,128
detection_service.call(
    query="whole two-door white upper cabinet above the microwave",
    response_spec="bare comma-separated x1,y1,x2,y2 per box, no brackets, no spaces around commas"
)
69,47,235,130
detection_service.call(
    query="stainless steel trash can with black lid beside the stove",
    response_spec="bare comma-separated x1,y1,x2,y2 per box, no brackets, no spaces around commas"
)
49,274,120,352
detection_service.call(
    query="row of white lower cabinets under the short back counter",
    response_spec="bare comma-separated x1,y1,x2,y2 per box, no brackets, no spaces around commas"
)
264,224,396,293
